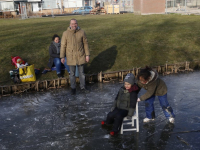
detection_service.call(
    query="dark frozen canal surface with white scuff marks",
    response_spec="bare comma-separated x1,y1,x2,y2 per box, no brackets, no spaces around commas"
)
0,72,200,150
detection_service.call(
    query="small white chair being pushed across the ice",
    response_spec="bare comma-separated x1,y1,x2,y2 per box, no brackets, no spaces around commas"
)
120,102,139,134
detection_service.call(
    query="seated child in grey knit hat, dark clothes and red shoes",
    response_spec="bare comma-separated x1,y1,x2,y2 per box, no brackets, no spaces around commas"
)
101,73,139,135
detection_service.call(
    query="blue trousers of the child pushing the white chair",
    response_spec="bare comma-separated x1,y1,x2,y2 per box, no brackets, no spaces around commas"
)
145,94,175,119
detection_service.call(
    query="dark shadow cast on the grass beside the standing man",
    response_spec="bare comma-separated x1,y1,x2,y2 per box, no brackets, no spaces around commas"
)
85,45,117,74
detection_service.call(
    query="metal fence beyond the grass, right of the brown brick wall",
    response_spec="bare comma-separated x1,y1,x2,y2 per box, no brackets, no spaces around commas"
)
165,0,200,14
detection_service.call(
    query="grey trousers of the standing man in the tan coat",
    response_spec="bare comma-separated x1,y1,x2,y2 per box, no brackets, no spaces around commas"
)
69,65,85,89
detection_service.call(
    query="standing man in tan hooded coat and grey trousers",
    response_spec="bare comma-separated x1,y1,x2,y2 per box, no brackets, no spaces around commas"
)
60,19,90,95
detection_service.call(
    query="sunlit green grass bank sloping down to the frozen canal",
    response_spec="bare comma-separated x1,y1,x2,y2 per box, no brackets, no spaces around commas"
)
0,14,200,85
